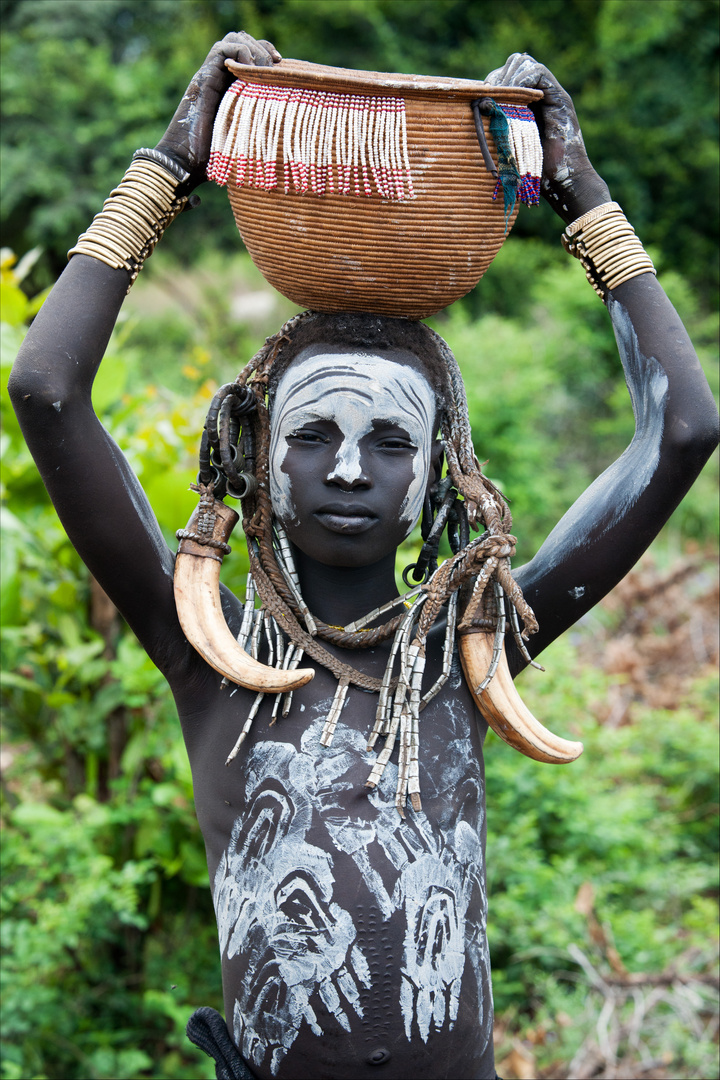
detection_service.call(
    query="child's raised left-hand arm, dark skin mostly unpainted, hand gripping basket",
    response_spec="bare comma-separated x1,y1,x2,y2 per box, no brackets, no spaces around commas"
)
9,33,279,671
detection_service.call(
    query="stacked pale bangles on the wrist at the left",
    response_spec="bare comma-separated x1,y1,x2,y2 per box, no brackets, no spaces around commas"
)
68,150,190,292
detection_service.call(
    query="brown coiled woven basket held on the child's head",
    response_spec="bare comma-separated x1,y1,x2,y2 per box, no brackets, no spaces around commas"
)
218,59,542,319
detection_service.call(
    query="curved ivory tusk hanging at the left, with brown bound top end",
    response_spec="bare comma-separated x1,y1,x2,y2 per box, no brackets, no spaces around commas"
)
174,500,315,693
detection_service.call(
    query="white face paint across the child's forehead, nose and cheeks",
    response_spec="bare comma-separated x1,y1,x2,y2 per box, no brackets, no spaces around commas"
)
270,353,435,535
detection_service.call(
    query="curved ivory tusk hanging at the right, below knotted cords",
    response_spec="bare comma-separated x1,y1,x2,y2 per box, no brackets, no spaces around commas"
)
460,631,583,765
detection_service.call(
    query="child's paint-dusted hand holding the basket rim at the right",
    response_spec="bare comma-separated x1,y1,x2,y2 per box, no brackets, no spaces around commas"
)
485,53,610,225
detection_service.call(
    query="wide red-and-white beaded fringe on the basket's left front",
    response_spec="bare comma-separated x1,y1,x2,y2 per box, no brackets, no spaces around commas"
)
207,79,415,201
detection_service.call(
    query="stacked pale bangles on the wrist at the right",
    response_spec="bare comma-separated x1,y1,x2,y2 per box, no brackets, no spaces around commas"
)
561,202,655,300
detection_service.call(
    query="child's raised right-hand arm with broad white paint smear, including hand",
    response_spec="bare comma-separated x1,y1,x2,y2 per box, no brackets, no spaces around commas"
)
487,54,718,671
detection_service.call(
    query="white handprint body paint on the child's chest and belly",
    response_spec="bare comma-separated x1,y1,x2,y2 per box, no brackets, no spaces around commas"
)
214,673,490,1076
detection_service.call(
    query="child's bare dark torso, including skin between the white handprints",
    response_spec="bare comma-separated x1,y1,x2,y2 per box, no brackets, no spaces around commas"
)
177,652,489,1076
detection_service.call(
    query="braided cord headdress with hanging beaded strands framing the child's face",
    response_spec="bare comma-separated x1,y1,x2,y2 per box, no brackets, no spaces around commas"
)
199,311,538,814
